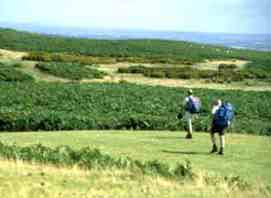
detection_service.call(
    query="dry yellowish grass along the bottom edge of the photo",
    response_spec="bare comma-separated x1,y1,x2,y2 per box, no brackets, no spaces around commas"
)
0,160,270,198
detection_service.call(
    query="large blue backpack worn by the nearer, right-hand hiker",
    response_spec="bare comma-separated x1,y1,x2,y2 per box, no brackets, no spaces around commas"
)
214,103,234,128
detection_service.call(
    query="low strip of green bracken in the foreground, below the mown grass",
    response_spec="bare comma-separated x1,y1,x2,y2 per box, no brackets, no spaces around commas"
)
0,142,194,180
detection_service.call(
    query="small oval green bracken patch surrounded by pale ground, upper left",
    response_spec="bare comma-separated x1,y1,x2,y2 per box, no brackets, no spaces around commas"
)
35,62,105,80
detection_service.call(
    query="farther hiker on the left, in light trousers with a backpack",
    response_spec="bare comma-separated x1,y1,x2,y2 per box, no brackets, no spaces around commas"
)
183,89,201,139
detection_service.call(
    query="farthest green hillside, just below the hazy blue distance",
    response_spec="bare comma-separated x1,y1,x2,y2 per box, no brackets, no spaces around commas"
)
0,28,271,63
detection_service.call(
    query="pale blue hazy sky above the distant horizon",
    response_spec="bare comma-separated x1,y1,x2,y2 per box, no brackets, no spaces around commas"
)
0,0,271,34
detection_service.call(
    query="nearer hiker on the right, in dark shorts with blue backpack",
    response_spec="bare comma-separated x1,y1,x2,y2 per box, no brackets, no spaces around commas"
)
210,100,234,155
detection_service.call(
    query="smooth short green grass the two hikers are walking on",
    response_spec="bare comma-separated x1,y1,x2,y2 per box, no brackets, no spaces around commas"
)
0,131,271,185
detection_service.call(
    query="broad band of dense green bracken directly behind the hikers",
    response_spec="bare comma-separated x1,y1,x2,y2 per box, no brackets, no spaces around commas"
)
0,83,271,135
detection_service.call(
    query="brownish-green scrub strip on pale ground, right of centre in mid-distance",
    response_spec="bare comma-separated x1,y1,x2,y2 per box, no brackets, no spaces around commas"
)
118,64,271,83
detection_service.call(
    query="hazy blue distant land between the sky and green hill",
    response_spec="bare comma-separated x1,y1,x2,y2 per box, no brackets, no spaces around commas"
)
0,22,271,51
